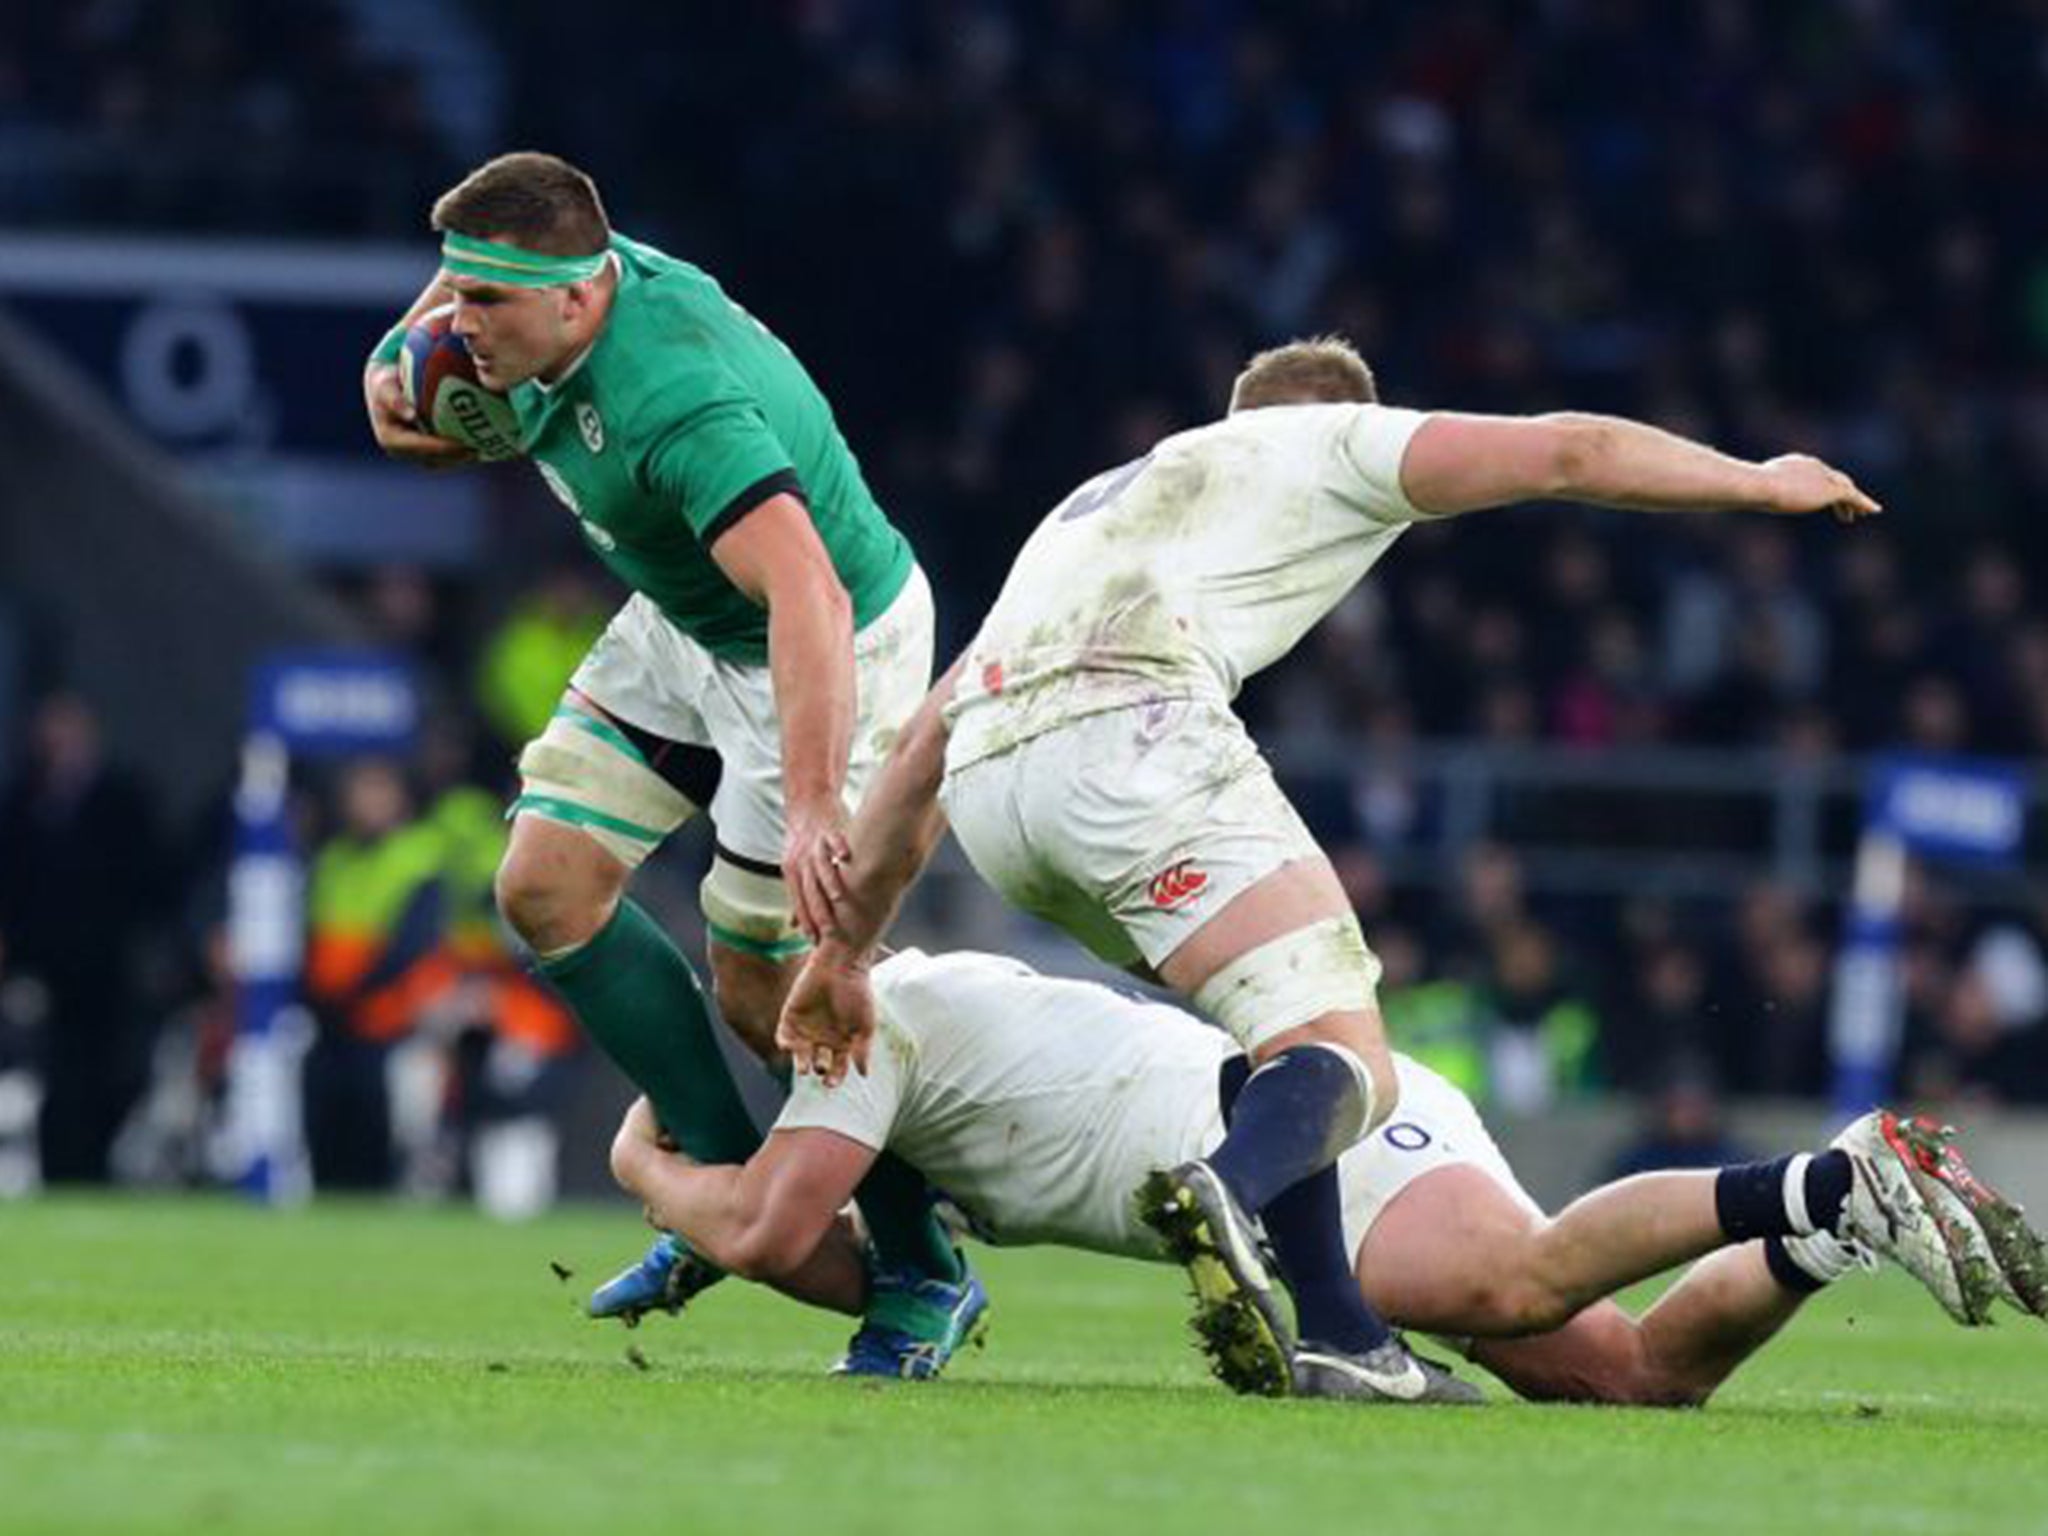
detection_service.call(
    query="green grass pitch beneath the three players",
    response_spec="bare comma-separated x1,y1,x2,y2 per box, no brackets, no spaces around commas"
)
0,1198,2048,1536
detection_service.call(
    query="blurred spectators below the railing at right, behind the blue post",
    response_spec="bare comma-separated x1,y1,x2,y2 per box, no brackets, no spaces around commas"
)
1335,844,2048,1114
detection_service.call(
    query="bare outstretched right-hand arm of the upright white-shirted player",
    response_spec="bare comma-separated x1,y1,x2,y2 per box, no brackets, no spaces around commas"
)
1401,412,1880,522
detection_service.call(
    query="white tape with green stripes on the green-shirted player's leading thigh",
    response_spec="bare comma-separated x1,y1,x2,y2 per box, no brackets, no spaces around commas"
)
512,713,696,868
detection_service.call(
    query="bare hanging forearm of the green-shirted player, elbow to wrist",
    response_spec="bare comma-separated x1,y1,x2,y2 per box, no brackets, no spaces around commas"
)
768,580,856,805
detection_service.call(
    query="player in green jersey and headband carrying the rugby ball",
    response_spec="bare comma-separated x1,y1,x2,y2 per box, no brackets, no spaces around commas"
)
365,154,987,1376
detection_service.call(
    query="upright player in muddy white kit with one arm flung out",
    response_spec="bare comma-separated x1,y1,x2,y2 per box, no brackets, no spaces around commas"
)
780,340,1878,1399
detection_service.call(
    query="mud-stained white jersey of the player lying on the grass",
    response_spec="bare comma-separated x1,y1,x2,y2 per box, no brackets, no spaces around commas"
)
776,950,1235,1257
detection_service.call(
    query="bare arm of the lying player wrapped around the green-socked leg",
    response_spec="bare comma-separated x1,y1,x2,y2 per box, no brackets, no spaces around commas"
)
612,1100,874,1313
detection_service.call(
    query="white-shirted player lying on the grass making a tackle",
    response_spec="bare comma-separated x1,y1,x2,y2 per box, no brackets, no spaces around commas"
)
612,950,2048,1405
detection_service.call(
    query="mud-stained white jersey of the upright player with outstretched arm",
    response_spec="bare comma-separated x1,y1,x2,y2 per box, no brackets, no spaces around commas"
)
946,406,1425,768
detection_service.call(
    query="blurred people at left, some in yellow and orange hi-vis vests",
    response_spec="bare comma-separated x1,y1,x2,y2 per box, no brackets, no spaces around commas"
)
0,569,608,1214
